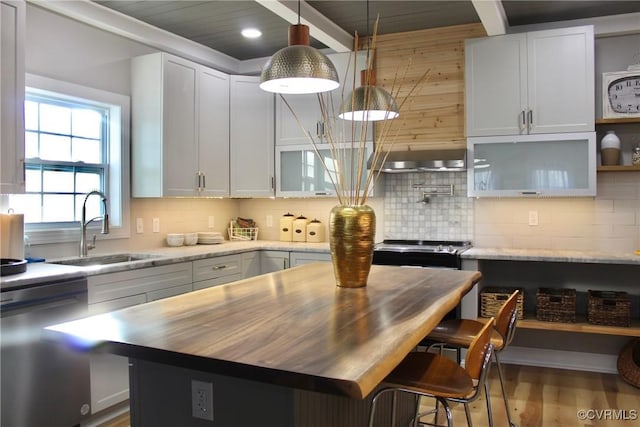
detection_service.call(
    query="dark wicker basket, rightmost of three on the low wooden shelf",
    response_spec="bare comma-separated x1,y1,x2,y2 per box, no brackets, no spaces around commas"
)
587,290,631,327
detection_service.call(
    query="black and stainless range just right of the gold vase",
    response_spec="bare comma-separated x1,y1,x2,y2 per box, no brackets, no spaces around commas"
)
373,240,471,270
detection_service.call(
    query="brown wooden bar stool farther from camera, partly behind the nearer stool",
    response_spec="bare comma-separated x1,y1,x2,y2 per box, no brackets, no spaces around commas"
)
426,290,520,427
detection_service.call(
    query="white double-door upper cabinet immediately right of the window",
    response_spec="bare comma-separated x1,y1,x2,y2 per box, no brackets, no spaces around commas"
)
131,53,229,197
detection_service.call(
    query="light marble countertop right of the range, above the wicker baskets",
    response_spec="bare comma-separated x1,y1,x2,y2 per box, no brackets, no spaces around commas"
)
462,247,640,265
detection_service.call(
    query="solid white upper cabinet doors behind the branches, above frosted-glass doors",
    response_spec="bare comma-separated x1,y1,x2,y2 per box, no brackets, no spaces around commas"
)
275,52,373,145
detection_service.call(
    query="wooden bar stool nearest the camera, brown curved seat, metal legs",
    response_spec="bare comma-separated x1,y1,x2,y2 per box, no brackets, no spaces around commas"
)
369,319,493,427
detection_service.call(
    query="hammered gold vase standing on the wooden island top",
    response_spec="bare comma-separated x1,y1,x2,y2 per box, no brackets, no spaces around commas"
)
329,205,376,288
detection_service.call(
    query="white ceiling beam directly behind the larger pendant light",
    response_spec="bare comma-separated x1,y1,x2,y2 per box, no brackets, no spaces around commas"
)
255,0,353,52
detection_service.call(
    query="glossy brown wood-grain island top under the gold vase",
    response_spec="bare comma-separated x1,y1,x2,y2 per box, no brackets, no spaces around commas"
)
46,263,481,399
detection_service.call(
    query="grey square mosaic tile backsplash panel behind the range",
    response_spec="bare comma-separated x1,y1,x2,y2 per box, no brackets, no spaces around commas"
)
384,172,473,240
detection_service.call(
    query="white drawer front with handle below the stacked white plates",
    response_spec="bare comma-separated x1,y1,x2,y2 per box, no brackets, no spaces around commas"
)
193,255,242,290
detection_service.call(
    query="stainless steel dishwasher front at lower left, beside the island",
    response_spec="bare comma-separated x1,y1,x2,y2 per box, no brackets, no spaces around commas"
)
0,279,91,427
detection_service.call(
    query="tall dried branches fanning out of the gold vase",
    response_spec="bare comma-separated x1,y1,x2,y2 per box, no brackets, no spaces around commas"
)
280,20,430,206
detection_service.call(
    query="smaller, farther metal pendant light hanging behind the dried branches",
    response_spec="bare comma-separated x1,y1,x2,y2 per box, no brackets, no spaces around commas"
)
338,0,400,122
